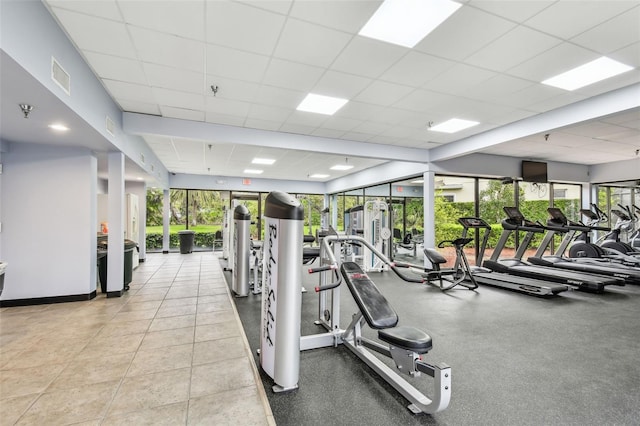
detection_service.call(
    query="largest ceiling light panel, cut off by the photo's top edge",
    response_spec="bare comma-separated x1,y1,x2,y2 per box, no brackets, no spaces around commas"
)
358,0,462,48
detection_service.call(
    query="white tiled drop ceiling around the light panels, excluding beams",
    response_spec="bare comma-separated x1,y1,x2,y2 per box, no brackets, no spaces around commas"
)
20,0,640,180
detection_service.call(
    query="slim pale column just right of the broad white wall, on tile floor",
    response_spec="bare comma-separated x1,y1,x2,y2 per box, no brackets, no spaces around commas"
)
107,152,125,297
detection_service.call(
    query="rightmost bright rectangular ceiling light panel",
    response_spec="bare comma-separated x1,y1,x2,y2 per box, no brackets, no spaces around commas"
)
542,56,633,90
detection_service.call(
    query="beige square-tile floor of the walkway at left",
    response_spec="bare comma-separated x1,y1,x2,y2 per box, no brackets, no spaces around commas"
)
0,252,275,426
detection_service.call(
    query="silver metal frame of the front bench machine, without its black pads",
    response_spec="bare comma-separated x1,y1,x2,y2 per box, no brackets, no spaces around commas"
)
300,234,451,414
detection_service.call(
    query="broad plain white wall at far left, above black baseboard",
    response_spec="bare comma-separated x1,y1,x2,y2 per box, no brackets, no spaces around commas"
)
0,144,97,300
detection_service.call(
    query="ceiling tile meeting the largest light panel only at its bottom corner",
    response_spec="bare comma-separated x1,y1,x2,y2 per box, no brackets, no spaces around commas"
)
380,51,456,87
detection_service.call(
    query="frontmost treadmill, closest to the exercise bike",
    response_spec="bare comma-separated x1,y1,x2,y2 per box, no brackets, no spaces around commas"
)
458,217,569,297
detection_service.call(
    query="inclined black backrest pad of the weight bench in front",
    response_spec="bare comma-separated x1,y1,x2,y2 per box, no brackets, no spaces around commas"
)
340,262,398,330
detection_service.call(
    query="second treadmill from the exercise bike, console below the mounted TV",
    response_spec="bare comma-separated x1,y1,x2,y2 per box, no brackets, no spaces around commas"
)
483,207,624,293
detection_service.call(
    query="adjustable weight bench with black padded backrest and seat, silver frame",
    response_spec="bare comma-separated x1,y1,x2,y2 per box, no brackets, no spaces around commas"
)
340,262,451,414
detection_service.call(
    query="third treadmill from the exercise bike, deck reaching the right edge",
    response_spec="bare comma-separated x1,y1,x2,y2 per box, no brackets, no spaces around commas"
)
527,207,640,284
